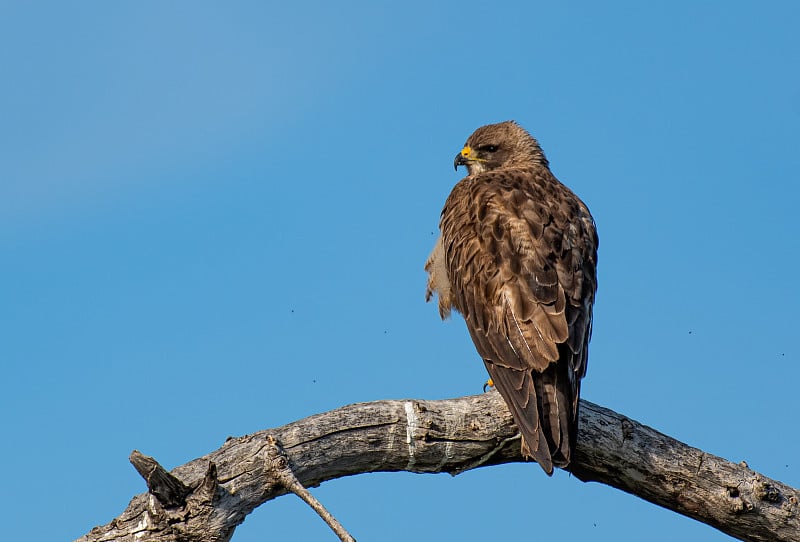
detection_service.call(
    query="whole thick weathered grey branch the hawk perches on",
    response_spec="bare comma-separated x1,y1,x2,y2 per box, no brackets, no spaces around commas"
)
79,392,800,542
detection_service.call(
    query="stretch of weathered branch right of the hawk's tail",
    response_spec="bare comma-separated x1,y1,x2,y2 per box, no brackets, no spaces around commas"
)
569,403,800,542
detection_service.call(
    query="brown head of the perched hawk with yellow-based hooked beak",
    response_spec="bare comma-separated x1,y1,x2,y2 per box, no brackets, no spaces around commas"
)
453,120,547,175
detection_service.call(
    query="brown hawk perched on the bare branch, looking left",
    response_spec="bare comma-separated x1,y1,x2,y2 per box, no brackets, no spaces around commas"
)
425,121,598,475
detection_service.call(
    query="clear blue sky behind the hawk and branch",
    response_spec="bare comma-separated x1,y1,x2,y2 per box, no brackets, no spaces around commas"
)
0,0,800,542
